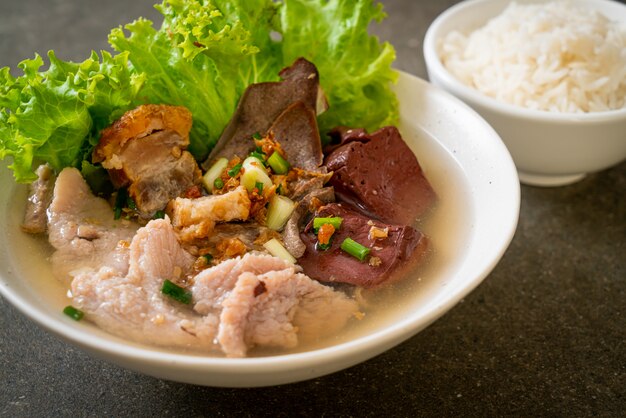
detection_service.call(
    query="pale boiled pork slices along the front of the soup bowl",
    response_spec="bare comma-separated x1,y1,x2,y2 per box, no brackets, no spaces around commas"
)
71,218,358,357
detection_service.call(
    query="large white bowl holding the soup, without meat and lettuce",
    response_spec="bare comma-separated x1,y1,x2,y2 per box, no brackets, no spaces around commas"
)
0,73,520,387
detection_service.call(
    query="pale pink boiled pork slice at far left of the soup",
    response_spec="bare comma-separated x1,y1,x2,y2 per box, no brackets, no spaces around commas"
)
47,168,137,283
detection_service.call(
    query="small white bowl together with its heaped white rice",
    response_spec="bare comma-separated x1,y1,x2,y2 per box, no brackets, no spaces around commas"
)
424,0,626,186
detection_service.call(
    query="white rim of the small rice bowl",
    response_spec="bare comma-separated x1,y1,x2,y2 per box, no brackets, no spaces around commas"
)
423,0,626,124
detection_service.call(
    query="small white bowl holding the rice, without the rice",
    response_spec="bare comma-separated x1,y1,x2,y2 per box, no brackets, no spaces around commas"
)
424,0,626,186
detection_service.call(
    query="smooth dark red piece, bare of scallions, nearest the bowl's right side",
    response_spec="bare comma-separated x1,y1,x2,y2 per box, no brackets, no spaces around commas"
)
324,126,436,225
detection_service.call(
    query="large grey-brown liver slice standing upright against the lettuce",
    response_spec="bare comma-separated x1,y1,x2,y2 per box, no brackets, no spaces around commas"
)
202,58,328,169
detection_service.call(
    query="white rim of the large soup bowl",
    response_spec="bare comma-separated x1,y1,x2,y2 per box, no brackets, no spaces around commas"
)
0,71,521,387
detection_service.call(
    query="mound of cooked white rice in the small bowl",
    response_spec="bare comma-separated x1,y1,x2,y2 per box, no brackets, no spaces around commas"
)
438,1,626,112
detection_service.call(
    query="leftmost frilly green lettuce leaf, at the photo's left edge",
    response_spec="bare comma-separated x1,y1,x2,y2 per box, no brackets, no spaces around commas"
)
0,51,143,182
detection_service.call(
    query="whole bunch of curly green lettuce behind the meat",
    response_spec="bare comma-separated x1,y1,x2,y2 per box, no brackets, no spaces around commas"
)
0,0,398,182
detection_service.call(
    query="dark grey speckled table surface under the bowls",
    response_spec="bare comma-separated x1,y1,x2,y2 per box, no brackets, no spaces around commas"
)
0,0,626,417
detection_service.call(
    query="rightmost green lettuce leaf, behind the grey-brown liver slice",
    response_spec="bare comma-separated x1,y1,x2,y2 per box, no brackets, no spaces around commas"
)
278,0,399,132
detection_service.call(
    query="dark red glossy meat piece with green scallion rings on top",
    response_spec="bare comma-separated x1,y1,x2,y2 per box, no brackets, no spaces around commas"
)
298,203,428,288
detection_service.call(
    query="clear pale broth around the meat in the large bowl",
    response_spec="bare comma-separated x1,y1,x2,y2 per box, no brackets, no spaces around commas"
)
3,123,472,356
